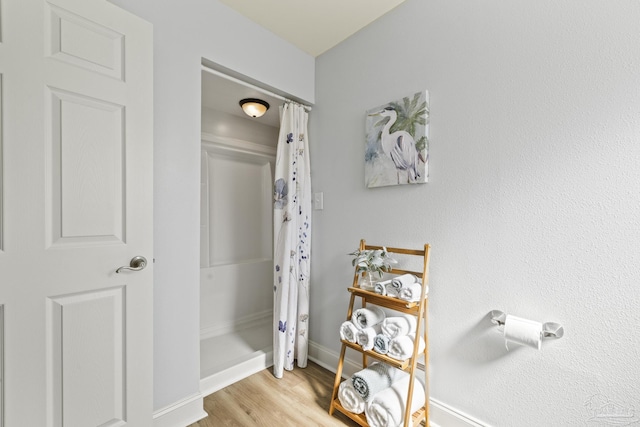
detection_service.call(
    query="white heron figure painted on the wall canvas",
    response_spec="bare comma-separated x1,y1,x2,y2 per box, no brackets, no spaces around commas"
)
370,107,421,184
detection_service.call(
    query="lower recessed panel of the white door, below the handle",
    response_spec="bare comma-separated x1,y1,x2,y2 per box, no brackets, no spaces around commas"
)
47,287,126,426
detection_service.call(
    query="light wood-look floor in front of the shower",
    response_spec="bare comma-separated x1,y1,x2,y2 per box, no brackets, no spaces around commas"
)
189,362,358,427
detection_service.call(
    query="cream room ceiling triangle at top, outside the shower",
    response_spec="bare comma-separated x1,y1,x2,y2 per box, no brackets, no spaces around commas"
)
220,0,405,57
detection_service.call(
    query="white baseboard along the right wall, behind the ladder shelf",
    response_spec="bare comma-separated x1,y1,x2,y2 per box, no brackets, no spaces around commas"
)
309,341,489,427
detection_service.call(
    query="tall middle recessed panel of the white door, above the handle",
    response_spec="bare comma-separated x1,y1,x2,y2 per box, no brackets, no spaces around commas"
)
46,89,125,245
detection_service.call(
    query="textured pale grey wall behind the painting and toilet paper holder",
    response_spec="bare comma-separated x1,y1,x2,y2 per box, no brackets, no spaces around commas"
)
310,0,640,427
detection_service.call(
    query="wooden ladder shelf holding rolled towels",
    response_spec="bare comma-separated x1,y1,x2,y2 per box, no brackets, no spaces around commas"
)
329,239,430,427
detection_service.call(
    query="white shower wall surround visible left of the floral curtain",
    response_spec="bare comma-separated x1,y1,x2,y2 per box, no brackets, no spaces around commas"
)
200,108,278,338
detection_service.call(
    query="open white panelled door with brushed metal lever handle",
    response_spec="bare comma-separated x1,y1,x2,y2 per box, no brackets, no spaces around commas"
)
0,0,153,427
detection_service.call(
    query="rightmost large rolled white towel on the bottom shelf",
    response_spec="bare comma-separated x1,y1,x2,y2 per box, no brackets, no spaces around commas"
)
364,371,425,427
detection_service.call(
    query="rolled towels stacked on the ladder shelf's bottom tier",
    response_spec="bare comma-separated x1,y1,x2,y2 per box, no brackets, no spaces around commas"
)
338,362,425,427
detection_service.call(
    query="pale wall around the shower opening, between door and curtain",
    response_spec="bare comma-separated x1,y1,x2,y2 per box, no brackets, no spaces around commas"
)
113,0,314,410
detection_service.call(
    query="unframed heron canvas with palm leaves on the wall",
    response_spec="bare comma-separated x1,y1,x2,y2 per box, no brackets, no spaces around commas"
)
364,91,429,188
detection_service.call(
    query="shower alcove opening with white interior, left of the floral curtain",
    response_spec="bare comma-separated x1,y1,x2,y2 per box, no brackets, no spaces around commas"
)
200,70,280,395
